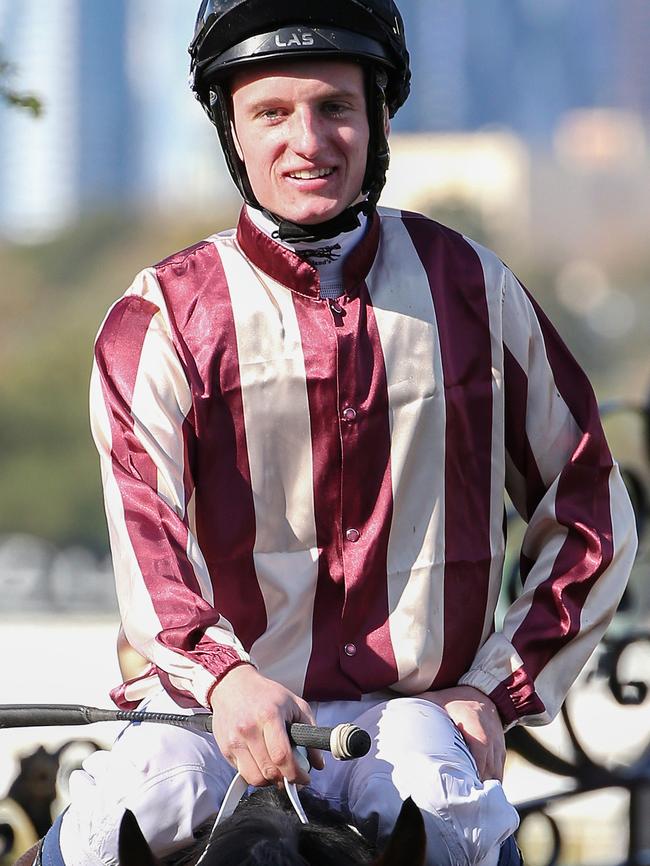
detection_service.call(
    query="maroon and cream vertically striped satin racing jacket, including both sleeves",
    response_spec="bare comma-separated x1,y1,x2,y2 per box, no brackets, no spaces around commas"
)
91,209,635,726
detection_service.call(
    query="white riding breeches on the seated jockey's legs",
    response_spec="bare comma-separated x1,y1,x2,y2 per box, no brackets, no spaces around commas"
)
61,692,518,866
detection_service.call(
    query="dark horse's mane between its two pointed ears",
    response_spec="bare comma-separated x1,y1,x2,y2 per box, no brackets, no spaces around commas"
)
162,788,376,866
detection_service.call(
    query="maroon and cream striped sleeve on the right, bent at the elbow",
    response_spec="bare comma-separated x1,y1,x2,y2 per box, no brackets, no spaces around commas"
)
461,270,636,728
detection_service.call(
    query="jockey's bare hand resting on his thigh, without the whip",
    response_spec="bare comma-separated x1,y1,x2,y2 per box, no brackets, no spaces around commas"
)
420,686,506,782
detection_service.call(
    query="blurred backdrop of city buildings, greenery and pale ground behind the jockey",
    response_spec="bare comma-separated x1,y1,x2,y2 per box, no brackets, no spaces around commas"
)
0,0,650,863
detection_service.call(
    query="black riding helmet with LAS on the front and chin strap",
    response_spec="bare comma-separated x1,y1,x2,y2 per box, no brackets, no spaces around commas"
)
189,0,411,240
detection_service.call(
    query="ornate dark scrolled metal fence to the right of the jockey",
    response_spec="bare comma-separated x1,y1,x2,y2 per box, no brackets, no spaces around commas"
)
506,402,650,866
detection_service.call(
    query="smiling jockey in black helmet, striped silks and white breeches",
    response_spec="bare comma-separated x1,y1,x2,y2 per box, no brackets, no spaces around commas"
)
35,0,635,866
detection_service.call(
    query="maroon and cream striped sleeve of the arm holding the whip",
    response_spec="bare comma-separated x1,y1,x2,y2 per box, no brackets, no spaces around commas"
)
90,271,249,706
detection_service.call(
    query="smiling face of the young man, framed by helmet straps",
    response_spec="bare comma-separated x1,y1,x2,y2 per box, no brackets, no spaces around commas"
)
232,61,370,225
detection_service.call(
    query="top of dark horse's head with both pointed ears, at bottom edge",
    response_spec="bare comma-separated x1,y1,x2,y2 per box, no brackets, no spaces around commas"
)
119,788,426,866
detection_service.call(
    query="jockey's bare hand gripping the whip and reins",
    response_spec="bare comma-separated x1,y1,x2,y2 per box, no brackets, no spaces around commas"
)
210,665,324,787
